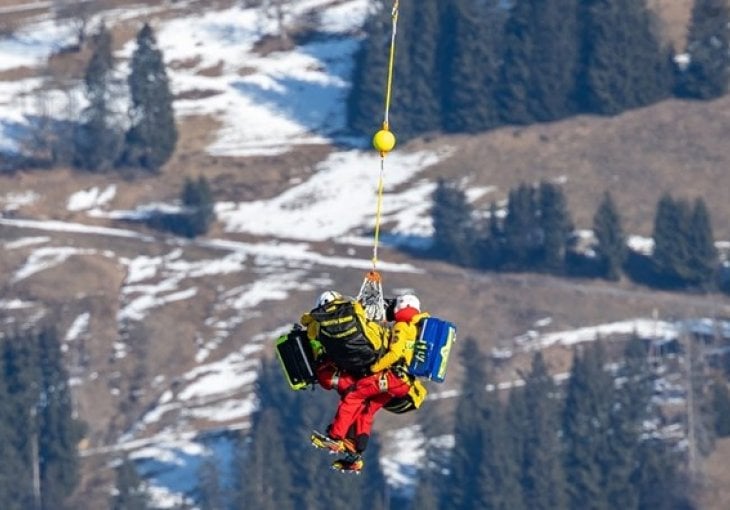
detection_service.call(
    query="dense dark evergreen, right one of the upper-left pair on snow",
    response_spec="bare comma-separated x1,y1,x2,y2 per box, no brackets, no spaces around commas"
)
125,24,177,172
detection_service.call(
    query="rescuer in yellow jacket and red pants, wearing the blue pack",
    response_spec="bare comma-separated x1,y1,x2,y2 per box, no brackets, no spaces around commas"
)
315,293,429,469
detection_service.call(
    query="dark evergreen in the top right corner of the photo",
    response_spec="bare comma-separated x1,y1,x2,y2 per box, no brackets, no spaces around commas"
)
678,0,730,99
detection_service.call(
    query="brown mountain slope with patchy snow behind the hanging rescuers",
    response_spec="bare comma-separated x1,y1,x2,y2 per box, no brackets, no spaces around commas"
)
0,0,730,508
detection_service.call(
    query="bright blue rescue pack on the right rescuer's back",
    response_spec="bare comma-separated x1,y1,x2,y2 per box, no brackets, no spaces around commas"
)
408,317,456,382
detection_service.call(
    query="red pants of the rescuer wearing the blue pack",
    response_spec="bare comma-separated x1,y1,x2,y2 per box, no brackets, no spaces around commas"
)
329,370,410,442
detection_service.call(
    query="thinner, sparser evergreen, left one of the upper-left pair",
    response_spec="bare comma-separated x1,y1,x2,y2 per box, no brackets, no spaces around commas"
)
74,24,123,172
